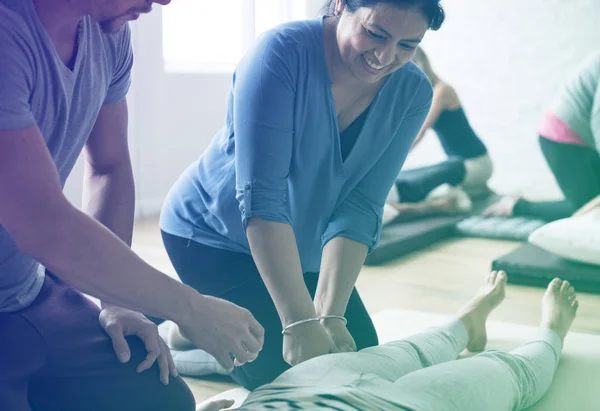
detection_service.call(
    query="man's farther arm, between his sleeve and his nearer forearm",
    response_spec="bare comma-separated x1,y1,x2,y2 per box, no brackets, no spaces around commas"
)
83,99,135,246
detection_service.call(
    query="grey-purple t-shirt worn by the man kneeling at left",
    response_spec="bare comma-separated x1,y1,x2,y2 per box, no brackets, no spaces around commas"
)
0,0,133,312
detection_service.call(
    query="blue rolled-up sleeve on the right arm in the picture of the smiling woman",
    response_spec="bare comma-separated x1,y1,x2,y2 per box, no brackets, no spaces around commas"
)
322,82,432,253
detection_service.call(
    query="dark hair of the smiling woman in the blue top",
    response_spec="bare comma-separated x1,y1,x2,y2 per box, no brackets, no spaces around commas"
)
322,0,446,30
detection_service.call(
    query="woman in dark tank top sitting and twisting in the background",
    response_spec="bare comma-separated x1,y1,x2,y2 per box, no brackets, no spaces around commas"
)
388,47,492,222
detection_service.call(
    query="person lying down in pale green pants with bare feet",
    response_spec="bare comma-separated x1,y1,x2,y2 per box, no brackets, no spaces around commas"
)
198,271,579,411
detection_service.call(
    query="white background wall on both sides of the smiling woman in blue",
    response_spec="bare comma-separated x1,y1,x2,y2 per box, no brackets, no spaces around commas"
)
66,0,600,215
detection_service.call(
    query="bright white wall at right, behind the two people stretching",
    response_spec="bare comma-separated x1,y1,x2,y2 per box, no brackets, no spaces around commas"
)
407,0,600,197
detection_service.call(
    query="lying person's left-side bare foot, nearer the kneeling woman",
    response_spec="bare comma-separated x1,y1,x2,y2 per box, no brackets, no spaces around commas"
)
457,271,506,352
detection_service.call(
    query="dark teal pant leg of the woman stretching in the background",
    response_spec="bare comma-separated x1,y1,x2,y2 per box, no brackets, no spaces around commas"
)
396,157,467,203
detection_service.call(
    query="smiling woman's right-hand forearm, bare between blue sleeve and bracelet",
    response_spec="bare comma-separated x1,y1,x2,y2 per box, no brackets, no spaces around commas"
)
315,237,368,315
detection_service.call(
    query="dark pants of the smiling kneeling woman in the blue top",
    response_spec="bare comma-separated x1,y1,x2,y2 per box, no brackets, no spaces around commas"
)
157,232,378,390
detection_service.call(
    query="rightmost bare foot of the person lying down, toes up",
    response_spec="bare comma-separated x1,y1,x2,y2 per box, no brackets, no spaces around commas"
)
541,278,579,340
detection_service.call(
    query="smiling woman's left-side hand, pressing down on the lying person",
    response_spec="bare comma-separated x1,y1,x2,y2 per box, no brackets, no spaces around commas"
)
283,321,339,366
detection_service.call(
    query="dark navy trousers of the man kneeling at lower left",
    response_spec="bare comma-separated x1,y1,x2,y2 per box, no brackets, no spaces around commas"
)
0,272,195,411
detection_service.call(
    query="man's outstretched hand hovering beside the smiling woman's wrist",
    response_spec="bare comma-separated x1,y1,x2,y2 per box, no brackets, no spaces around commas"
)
178,294,265,371
